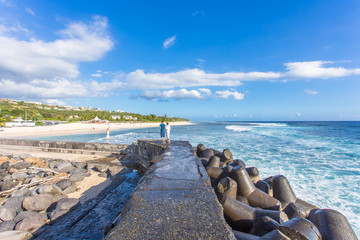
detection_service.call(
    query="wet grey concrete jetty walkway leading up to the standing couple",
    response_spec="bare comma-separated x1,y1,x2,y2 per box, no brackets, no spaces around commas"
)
106,140,235,240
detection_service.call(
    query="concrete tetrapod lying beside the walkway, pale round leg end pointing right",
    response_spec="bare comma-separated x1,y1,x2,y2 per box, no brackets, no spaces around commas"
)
220,195,288,232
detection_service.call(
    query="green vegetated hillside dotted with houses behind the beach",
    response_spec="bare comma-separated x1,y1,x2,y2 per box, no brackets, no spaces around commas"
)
0,99,189,125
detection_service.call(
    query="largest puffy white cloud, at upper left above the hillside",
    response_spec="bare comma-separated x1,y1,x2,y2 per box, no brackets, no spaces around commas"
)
0,16,113,82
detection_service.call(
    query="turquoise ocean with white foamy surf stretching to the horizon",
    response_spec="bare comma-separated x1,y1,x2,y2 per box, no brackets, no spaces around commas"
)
41,122,360,236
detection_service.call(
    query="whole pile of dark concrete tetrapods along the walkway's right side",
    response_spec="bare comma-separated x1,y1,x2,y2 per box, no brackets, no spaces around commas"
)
194,144,358,240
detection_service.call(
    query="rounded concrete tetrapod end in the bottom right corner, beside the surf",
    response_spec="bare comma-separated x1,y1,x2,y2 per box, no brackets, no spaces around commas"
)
313,209,358,240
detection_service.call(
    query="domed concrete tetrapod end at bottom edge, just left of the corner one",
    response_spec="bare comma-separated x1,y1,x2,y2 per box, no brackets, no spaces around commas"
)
278,218,321,240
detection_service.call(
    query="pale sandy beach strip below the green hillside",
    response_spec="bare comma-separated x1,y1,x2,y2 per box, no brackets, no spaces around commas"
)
0,122,193,138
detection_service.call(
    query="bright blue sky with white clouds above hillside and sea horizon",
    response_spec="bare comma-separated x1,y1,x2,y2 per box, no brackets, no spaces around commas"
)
0,0,360,121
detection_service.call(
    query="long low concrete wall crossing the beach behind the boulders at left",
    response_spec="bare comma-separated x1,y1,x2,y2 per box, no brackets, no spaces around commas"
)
0,139,129,152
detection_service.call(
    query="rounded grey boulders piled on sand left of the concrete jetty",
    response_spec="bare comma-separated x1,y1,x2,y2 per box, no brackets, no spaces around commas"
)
0,146,135,239
